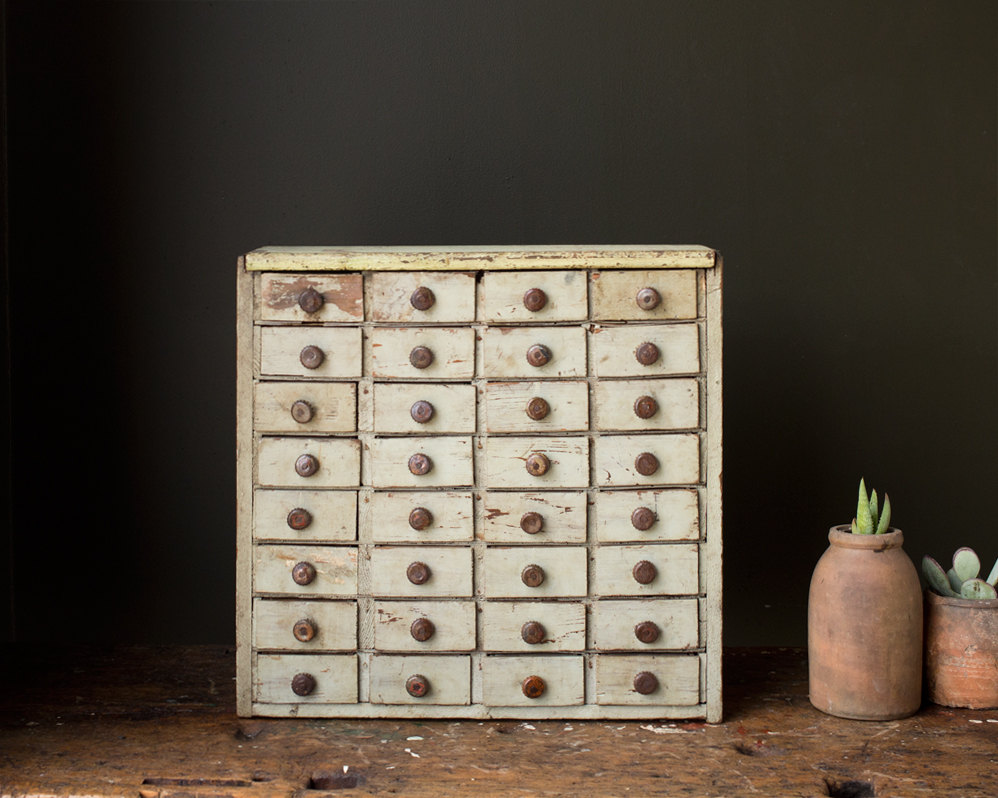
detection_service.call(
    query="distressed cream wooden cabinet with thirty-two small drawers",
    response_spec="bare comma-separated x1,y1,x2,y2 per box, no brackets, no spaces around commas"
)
237,247,721,721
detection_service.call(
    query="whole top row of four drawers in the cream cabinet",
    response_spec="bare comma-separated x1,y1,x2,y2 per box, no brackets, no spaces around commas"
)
257,269,697,324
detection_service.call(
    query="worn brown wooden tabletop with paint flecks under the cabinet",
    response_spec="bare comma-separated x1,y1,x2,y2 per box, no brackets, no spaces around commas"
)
0,646,998,798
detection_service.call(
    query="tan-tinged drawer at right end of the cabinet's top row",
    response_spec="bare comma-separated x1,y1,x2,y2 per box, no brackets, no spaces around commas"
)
591,269,697,321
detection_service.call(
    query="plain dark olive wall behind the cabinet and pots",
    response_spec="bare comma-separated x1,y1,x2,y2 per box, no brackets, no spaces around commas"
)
0,0,998,645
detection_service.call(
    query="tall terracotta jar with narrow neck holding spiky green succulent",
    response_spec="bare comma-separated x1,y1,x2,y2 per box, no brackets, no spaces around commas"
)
807,526,922,720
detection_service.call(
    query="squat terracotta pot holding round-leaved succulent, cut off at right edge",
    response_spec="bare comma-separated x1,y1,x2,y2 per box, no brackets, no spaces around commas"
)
925,590,998,709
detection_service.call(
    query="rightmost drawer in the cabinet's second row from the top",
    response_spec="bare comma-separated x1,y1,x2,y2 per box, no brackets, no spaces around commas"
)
590,324,700,377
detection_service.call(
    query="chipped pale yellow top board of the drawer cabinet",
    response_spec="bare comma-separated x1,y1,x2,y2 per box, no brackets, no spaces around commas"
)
244,244,718,272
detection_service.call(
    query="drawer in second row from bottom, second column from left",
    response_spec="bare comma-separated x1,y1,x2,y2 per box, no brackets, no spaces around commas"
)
374,601,475,651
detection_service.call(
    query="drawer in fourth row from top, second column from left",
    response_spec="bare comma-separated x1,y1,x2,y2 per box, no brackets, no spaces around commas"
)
370,437,474,488
